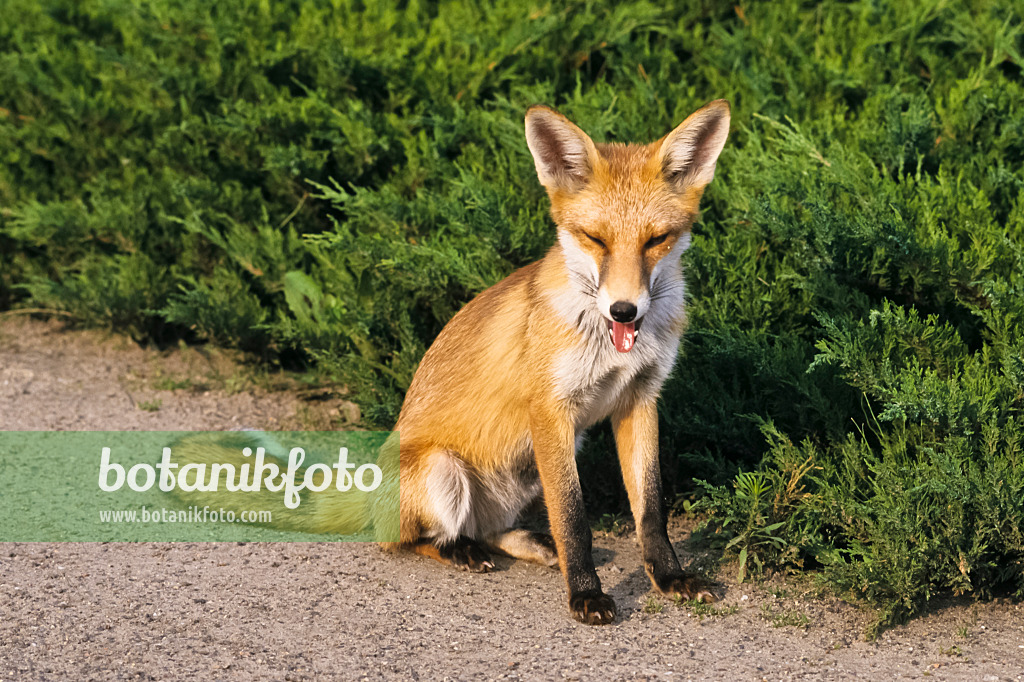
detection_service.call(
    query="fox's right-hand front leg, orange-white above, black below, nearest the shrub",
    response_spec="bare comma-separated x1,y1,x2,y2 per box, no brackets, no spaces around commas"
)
611,399,715,602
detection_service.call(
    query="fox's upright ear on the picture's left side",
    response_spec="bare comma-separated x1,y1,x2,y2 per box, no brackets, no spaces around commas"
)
526,105,598,191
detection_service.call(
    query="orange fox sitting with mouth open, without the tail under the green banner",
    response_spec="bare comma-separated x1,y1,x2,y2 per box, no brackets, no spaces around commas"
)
391,99,729,625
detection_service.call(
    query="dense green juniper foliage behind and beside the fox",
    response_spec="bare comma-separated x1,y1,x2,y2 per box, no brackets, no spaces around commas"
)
0,0,1024,624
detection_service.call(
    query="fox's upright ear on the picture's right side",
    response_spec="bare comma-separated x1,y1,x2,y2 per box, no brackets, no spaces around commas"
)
660,99,729,191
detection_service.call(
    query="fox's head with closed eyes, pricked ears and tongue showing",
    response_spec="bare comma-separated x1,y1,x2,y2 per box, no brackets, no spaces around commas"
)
526,99,729,352
